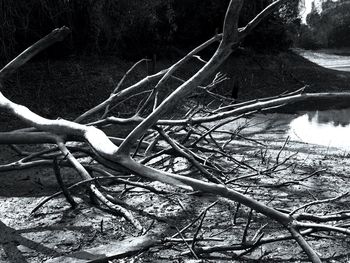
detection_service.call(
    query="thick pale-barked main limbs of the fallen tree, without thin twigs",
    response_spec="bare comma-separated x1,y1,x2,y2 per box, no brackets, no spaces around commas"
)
0,0,330,262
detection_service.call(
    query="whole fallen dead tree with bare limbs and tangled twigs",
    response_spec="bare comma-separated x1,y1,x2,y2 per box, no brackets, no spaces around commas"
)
0,0,350,262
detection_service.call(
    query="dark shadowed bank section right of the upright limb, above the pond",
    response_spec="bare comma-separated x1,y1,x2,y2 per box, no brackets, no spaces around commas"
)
216,51,350,100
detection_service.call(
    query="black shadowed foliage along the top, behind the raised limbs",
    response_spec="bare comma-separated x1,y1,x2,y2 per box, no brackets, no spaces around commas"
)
0,0,299,59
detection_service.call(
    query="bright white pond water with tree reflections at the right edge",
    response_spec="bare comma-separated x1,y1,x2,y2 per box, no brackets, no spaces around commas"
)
289,109,350,149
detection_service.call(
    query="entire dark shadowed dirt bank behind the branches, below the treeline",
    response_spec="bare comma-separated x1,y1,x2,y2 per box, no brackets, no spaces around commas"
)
0,51,350,126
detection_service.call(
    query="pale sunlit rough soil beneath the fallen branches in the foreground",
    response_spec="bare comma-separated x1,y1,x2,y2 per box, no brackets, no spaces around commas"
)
0,114,350,263
